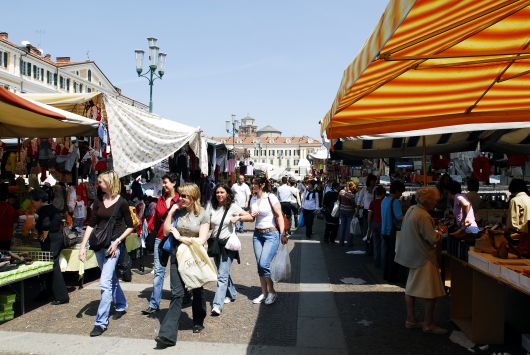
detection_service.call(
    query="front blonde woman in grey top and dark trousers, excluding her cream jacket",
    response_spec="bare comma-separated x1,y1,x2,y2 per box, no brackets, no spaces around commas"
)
155,183,210,348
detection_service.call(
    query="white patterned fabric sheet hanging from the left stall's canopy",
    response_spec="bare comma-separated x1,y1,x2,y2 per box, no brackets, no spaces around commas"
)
103,95,208,177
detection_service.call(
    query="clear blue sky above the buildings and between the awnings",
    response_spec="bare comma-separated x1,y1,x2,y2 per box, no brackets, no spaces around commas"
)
0,0,387,138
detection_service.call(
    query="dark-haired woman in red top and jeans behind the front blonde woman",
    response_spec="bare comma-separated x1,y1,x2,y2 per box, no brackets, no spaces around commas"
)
142,174,179,315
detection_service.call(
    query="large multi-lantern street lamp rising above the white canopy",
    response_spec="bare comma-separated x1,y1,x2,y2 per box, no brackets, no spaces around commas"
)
134,37,166,112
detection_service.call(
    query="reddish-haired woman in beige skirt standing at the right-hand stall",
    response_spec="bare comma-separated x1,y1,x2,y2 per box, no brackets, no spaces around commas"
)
395,187,447,334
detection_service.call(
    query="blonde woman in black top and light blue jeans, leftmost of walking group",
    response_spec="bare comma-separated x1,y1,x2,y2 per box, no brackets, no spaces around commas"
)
79,171,134,337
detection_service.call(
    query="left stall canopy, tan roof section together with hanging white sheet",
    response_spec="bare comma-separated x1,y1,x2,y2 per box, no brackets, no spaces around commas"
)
24,93,208,177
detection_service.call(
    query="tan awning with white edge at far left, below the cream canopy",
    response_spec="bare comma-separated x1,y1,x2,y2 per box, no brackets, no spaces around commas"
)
0,87,98,138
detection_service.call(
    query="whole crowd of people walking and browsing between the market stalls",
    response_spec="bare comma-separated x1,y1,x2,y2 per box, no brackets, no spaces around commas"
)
0,171,530,348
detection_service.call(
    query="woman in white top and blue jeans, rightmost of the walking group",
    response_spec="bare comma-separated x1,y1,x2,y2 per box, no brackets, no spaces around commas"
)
246,177,289,305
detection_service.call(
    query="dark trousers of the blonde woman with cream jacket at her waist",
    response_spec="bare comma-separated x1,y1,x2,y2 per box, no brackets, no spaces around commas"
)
158,253,206,343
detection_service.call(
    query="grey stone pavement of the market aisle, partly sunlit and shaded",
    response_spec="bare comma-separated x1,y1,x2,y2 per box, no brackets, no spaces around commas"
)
0,219,520,355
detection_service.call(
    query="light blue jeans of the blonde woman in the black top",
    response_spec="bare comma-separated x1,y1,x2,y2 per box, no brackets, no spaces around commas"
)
94,248,127,328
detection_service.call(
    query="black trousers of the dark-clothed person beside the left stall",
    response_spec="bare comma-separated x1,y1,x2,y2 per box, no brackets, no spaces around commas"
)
41,232,69,302
